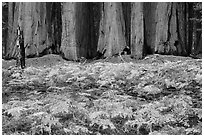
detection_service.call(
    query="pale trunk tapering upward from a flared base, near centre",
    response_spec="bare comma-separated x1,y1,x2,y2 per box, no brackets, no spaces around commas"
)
98,2,126,57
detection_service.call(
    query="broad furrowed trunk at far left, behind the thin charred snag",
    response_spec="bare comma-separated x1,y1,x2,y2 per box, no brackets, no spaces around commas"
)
6,2,61,57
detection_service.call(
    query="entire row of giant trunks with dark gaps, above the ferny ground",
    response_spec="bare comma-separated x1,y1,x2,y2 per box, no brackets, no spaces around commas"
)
2,2,202,60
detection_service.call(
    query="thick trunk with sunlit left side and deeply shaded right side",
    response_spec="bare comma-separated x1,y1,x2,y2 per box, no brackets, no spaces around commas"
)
61,2,96,60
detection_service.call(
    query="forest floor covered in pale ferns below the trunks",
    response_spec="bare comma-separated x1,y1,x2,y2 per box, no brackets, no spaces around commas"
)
2,55,202,135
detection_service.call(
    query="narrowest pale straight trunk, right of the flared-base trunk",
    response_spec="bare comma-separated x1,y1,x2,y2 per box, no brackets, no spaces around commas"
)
131,2,144,59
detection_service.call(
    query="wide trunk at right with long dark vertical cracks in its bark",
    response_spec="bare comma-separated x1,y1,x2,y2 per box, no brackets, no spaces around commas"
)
155,2,187,55
